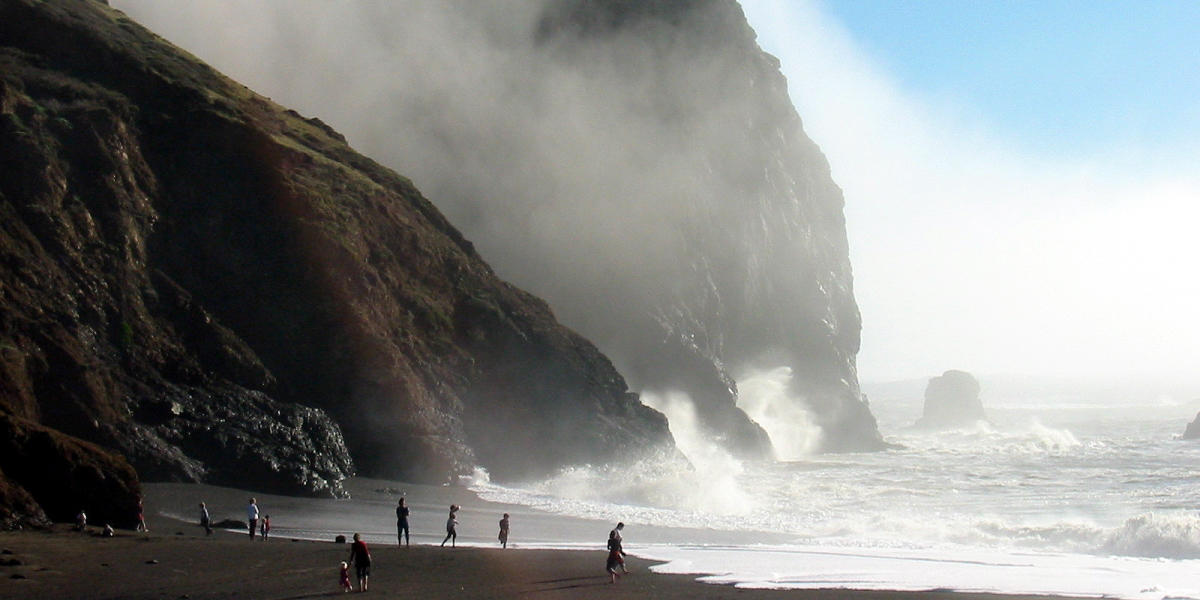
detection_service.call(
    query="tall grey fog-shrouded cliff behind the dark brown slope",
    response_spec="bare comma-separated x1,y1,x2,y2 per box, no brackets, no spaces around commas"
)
113,0,878,454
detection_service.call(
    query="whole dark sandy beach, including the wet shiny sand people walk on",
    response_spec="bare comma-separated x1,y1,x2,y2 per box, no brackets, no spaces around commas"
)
0,479,1075,600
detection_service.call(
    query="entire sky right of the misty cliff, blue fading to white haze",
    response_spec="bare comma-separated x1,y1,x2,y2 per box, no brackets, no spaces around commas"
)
743,0,1200,382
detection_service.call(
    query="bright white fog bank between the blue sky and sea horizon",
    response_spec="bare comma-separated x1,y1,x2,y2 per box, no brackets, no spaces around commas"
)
743,0,1200,380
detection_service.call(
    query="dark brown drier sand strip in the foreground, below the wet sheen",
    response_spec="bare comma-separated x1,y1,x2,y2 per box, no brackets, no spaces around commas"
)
0,521,1070,600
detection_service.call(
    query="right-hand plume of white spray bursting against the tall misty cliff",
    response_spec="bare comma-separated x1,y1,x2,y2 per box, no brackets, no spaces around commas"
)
737,367,821,461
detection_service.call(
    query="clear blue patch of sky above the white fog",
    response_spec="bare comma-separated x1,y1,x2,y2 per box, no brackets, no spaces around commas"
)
821,0,1200,157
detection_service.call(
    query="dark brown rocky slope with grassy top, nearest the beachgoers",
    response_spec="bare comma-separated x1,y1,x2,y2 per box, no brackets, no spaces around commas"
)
0,0,671,517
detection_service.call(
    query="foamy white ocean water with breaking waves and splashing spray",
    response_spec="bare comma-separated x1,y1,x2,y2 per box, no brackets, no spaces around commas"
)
472,370,1200,599
